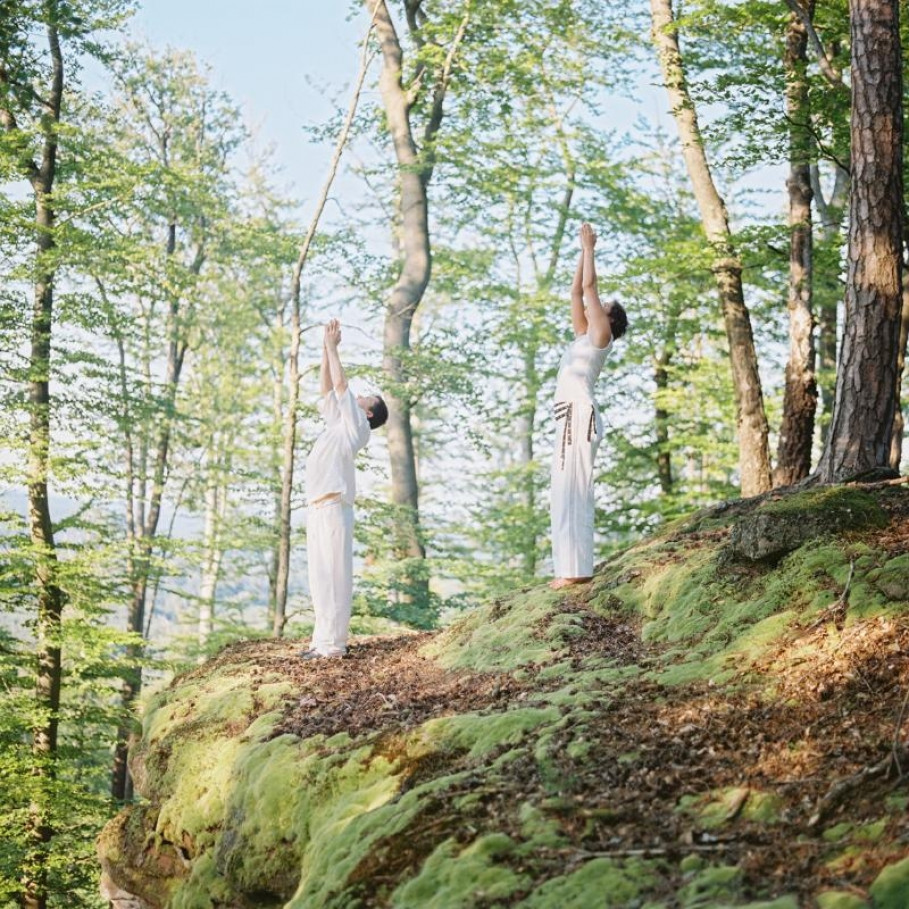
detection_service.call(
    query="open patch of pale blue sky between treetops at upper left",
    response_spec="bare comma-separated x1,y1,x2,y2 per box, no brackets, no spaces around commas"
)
127,0,367,200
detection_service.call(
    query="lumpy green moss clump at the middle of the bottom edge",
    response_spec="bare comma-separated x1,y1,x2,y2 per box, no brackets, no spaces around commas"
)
391,833,530,909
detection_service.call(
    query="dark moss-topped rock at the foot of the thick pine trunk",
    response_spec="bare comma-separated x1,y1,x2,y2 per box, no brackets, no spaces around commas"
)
729,486,888,562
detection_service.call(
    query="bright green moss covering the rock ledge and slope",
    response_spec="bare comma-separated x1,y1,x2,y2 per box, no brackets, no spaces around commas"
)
99,497,909,909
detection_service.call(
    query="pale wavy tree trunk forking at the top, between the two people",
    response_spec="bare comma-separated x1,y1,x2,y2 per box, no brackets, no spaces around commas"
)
365,0,469,603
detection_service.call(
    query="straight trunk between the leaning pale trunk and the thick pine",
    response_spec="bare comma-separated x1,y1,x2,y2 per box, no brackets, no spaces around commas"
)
773,0,817,486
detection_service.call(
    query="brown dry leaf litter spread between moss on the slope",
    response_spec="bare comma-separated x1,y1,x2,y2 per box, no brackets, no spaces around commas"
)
200,482,909,902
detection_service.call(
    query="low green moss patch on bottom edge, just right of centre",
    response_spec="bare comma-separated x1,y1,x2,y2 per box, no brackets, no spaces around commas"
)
517,858,656,909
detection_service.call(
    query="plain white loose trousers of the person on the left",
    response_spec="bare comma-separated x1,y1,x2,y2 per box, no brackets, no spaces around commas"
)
306,499,353,656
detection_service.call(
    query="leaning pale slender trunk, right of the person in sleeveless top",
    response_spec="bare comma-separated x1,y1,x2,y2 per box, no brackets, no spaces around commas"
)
650,0,770,497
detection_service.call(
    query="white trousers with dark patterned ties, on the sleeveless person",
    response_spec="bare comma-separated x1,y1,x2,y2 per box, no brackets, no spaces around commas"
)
549,401,603,578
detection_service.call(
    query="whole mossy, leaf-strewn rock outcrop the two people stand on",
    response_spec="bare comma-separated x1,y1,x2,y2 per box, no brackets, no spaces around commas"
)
99,485,909,909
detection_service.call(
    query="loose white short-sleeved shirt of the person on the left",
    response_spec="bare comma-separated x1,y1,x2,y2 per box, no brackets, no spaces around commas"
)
306,388,369,505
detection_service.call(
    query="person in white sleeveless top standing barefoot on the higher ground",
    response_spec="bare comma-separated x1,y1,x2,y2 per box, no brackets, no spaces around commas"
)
550,223,628,590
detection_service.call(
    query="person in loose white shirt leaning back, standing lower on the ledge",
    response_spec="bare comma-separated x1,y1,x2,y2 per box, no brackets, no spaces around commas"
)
301,319,388,660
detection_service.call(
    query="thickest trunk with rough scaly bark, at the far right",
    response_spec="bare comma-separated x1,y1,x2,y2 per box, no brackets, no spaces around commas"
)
818,0,903,482
